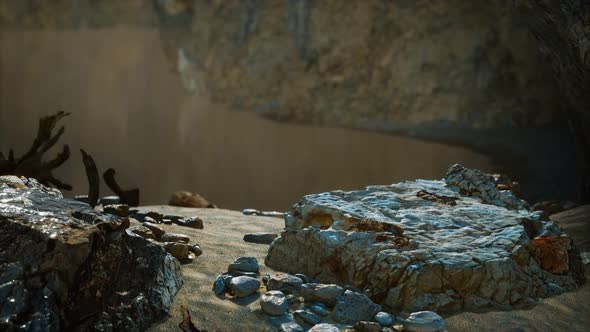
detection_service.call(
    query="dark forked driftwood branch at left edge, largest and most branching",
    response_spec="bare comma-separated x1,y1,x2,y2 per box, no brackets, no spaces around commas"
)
0,111,72,190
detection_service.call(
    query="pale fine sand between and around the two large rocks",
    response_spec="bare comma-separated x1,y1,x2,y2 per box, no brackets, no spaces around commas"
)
143,206,590,332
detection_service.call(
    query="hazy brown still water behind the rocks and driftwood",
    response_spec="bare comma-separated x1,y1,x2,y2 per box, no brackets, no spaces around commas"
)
0,28,491,210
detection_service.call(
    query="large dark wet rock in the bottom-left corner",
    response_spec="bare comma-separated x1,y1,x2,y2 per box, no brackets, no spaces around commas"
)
0,177,182,331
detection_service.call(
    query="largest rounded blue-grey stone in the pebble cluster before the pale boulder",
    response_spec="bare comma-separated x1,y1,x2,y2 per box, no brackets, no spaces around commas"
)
334,290,381,324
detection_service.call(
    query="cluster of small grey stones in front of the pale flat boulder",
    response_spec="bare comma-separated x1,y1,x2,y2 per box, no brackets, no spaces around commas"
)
213,257,445,332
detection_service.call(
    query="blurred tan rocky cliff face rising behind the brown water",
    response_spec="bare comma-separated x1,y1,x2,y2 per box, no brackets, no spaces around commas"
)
157,0,560,132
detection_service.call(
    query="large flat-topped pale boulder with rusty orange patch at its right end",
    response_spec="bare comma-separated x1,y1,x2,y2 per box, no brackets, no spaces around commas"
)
266,165,584,312
